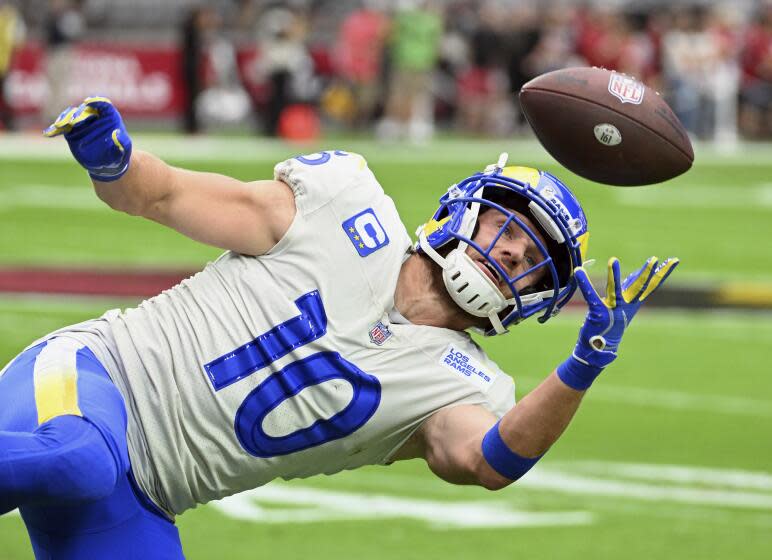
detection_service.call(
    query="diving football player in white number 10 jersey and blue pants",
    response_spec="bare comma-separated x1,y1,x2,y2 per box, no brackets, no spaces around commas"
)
0,97,678,560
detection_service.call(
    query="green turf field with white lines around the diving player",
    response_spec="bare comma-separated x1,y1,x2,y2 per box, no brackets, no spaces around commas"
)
0,136,772,560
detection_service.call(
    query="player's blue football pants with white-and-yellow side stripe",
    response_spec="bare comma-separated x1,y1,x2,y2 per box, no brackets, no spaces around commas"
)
0,338,184,560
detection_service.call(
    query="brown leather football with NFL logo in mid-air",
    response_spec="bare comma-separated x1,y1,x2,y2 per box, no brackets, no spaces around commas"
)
520,67,694,186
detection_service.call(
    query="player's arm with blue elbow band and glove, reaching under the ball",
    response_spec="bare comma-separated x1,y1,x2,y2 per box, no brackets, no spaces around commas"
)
396,258,678,489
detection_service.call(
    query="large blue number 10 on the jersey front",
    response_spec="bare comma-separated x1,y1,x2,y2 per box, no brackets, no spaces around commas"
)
204,291,381,457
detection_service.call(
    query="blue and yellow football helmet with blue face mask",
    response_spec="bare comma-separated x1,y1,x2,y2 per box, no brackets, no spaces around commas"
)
415,154,589,336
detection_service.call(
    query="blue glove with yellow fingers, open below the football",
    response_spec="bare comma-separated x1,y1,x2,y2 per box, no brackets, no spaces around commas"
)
557,257,679,391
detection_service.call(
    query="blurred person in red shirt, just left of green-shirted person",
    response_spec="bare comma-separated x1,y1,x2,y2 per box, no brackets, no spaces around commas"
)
333,0,389,127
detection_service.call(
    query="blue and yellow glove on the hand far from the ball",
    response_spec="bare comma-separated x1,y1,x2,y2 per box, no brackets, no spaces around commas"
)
43,97,131,181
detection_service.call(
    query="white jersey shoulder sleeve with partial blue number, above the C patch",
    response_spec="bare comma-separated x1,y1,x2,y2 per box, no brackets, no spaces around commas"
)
274,150,383,216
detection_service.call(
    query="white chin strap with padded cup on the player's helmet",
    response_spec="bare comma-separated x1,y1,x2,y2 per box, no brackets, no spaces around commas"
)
418,232,516,334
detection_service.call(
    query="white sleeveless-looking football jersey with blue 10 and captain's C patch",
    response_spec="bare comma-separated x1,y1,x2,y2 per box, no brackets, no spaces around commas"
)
56,151,514,514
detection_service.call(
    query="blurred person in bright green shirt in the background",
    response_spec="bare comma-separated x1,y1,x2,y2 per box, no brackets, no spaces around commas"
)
378,0,443,142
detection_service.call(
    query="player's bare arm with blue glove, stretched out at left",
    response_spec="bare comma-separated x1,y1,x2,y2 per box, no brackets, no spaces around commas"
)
45,97,295,255
